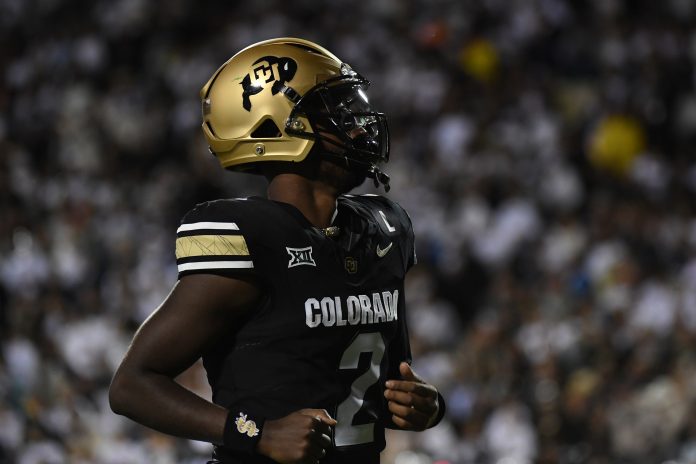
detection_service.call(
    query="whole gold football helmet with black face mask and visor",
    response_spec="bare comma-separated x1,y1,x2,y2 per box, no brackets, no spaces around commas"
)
200,38,389,189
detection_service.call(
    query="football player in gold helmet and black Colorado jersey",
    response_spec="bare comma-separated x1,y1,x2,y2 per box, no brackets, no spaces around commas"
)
109,38,444,464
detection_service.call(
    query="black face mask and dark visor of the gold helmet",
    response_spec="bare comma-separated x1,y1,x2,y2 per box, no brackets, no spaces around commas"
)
285,74,389,190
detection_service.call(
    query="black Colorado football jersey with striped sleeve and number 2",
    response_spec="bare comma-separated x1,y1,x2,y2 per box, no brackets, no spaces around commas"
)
176,195,415,464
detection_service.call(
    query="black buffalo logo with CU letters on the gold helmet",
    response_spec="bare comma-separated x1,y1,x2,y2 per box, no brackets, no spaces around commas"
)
240,56,297,111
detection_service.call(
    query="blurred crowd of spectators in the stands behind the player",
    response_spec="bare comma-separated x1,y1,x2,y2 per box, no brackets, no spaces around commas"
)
0,0,696,464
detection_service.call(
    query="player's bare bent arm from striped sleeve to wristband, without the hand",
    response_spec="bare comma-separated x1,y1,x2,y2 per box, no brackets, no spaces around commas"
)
109,274,261,443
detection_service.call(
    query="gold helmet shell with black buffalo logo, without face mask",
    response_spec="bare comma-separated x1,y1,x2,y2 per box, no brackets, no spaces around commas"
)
200,37,342,170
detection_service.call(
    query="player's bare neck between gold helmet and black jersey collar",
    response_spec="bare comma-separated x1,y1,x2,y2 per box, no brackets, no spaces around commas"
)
268,174,338,228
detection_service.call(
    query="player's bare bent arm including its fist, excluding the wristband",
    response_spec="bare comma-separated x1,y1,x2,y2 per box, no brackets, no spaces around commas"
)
109,274,336,463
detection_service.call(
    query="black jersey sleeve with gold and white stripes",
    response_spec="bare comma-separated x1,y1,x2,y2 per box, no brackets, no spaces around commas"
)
176,202,254,278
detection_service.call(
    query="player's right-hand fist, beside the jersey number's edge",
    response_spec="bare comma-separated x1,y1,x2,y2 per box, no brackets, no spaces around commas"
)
384,362,440,430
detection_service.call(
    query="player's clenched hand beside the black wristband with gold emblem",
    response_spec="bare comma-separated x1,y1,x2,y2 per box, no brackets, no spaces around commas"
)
256,409,336,464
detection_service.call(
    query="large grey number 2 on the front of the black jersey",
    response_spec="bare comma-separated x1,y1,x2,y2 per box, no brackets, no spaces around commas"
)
334,332,384,446
